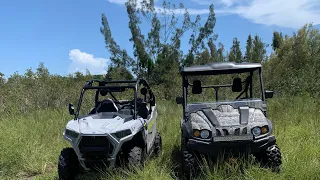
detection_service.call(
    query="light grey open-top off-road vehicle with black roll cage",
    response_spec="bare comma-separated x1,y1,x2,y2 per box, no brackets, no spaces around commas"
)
58,79,162,179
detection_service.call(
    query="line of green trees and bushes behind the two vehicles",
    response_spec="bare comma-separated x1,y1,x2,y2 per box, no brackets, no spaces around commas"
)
0,0,320,114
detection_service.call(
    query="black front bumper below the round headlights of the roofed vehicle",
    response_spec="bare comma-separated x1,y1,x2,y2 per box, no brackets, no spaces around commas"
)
187,136,276,156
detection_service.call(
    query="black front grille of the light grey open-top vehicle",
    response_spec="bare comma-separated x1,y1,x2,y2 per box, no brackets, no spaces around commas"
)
79,136,114,159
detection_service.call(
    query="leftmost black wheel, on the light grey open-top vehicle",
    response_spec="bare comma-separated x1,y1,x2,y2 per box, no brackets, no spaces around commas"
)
58,148,79,180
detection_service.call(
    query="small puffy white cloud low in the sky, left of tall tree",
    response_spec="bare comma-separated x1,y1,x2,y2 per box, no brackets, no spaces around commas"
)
69,49,109,74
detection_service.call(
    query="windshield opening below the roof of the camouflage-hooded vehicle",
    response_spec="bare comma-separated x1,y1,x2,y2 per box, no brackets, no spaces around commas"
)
186,70,262,103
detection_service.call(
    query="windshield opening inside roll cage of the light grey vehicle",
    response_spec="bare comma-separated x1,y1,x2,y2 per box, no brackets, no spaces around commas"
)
78,87,134,117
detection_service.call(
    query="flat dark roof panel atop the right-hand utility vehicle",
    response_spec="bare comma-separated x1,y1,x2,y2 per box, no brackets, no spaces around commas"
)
180,62,261,75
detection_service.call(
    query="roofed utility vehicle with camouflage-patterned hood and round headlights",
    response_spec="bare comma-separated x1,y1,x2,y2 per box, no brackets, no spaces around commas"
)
176,62,281,177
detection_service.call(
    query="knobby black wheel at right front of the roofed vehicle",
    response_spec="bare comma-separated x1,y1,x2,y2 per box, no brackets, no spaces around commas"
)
256,144,282,173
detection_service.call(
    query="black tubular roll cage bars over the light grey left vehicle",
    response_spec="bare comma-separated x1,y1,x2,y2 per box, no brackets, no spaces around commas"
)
74,78,155,120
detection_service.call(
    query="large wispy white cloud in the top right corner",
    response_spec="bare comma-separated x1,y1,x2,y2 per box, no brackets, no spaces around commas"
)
224,0,320,28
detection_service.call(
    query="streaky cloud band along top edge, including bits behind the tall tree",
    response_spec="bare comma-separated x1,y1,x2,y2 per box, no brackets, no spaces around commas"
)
108,0,320,29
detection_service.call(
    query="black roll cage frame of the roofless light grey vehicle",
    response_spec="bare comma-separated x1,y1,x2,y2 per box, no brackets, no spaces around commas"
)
74,78,155,120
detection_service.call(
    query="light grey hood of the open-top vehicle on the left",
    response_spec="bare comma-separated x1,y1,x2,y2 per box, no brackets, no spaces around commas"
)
67,113,132,134
